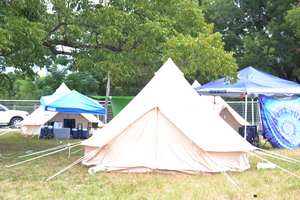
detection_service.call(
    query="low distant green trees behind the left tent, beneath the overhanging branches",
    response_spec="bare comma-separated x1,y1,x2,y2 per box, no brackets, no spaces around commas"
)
0,66,105,100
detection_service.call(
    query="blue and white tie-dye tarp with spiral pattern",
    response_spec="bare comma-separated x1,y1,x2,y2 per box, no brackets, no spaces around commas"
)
259,95,300,149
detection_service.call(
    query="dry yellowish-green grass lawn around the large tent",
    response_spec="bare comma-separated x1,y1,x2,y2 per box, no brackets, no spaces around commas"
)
0,133,300,200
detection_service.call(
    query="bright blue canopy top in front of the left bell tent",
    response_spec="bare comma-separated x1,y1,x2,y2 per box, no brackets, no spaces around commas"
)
40,90,106,115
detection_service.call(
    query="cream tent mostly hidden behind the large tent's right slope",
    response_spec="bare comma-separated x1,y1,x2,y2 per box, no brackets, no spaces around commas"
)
192,80,249,131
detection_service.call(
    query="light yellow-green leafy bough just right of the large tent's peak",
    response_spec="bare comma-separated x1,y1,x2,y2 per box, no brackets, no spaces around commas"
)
165,33,237,82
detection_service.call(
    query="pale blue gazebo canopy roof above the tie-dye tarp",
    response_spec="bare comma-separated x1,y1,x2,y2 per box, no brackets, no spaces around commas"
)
196,66,300,96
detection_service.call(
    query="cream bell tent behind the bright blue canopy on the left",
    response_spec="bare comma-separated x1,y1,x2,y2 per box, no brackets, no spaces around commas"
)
21,83,103,135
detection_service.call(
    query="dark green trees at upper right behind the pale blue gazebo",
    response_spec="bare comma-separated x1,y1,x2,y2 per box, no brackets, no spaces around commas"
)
202,0,300,81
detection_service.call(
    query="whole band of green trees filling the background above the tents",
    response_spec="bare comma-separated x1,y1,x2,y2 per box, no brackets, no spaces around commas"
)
0,0,300,99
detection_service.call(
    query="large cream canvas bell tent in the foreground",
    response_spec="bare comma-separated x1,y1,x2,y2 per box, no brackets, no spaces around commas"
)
82,59,255,173
